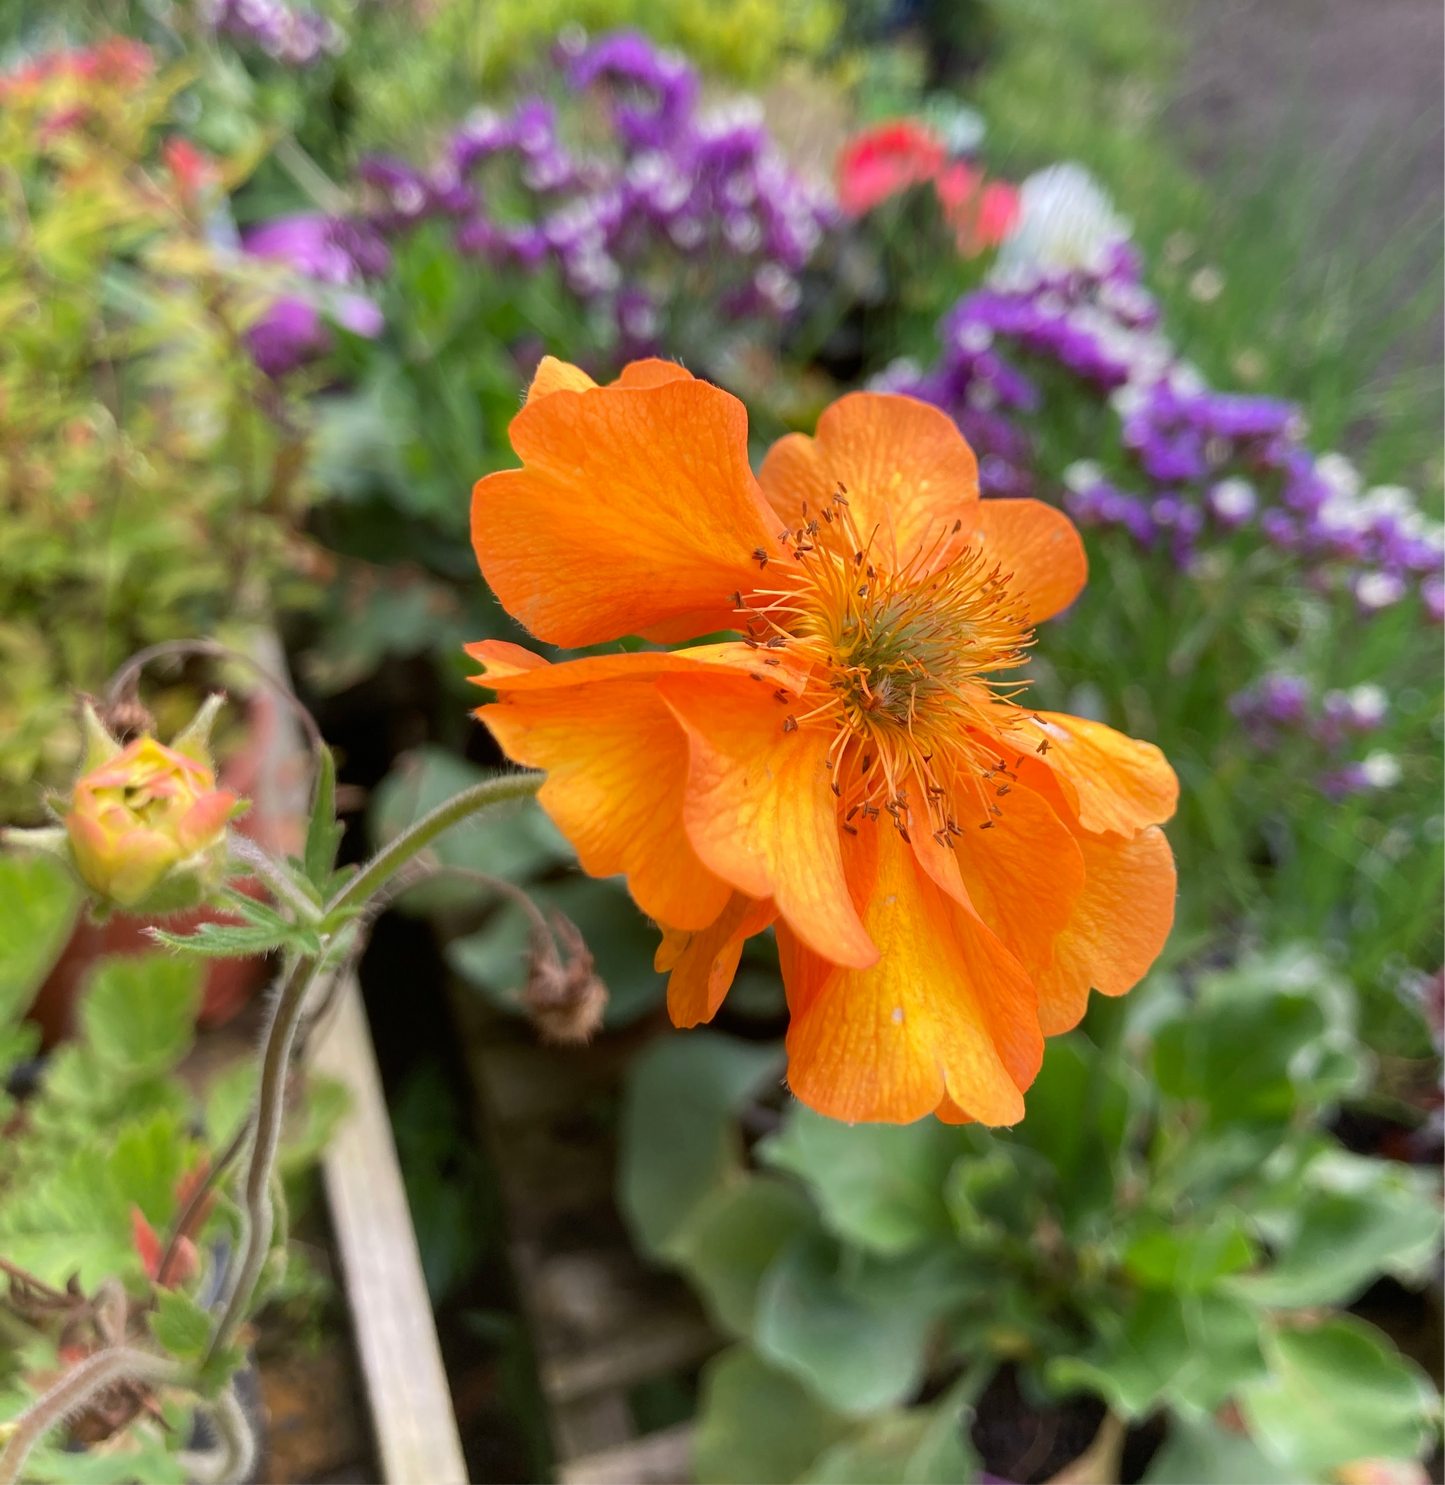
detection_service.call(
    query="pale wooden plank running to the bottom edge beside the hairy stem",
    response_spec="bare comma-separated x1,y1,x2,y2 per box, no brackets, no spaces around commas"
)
312,980,468,1485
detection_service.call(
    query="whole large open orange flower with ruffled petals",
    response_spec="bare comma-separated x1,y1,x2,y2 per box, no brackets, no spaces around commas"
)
468,358,1178,1124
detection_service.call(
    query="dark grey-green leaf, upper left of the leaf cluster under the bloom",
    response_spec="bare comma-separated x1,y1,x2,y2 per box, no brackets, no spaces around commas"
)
618,1031,783,1258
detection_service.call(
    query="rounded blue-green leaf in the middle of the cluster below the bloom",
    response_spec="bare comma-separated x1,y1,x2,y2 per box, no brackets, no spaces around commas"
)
754,1234,956,1415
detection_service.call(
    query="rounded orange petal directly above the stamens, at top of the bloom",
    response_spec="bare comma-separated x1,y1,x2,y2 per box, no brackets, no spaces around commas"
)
757,392,979,570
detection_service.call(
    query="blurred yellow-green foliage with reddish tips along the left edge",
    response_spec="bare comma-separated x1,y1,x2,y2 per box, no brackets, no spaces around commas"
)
0,42,314,820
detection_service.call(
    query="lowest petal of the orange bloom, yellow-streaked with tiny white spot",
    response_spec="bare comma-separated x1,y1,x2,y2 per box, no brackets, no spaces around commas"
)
778,826,1044,1124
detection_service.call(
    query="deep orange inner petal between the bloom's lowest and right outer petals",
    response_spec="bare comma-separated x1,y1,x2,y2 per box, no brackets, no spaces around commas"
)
953,787,1084,982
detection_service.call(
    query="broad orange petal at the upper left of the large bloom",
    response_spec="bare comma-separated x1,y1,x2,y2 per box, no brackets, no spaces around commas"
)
472,373,781,646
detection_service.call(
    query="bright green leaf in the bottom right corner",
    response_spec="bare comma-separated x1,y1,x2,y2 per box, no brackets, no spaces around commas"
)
1239,1316,1441,1475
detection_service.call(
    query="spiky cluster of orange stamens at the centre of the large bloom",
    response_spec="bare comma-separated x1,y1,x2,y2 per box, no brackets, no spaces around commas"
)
746,486,1032,839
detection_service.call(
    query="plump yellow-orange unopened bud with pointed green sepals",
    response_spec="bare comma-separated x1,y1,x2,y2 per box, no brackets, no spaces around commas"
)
64,696,247,912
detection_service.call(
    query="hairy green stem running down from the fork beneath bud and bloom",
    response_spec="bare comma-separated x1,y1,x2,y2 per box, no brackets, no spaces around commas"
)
206,959,321,1360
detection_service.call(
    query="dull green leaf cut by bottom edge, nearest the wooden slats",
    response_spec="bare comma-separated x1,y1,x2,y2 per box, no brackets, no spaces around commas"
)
694,1345,849,1485
